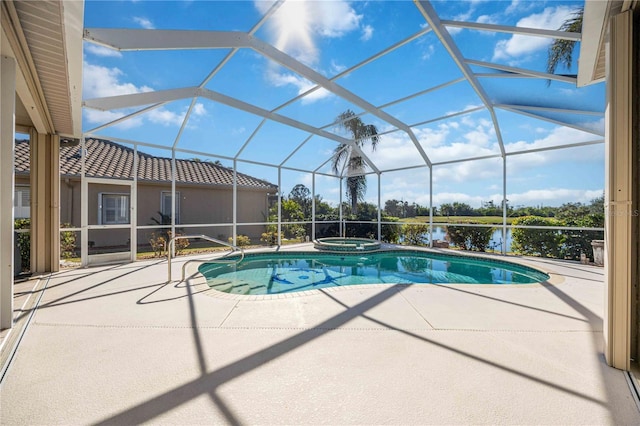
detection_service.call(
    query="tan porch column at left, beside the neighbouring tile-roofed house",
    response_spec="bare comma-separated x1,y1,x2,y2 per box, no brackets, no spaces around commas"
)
30,130,60,273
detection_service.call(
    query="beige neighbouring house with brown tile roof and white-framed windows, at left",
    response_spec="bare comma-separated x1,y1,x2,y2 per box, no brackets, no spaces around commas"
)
14,139,278,253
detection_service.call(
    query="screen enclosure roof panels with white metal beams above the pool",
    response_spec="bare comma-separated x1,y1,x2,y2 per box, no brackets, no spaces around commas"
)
83,1,605,181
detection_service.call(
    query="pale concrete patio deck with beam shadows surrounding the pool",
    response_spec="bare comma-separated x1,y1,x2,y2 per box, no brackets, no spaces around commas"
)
0,246,640,425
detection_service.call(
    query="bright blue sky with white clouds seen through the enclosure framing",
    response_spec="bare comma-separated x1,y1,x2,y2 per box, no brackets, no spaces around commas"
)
83,0,604,210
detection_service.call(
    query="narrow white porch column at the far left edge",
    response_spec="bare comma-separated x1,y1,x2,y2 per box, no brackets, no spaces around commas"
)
0,56,16,329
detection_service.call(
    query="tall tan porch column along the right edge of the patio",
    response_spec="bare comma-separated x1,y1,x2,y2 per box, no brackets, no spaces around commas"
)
603,11,634,370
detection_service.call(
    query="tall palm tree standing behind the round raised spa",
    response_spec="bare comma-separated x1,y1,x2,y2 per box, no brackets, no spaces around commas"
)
332,109,380,215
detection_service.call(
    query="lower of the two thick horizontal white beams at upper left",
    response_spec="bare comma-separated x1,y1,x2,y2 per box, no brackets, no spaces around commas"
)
83,87,199,111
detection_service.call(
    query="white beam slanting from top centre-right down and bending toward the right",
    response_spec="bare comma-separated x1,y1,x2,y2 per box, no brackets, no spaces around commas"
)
413,0,505,156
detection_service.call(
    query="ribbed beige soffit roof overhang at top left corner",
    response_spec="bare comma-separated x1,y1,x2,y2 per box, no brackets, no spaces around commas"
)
1,0,84,137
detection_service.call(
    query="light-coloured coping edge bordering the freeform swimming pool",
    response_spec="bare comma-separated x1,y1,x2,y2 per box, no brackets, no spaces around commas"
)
185,244,566,301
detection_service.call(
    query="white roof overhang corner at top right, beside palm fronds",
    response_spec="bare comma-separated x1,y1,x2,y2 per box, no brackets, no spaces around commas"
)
578,0,637,87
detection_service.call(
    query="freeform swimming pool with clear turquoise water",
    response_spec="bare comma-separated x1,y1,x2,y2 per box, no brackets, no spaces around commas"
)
198,250,549,295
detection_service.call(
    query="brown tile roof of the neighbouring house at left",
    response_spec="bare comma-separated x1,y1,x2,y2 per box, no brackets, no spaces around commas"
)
15,139,277,190
